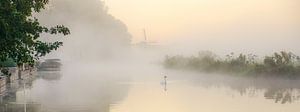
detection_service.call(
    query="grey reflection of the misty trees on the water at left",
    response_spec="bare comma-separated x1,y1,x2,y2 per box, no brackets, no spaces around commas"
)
0,65,128,112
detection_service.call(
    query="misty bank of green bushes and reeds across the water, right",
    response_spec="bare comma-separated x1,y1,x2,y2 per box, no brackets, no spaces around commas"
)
163,51,300,78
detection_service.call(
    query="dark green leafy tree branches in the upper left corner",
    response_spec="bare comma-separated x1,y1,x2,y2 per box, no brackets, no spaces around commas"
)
0,0,70,64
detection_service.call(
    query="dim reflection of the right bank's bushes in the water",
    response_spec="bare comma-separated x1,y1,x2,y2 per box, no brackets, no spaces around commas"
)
185,72,300,104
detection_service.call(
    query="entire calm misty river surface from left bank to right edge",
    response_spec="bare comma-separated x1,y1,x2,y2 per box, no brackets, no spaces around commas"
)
2,60,300,112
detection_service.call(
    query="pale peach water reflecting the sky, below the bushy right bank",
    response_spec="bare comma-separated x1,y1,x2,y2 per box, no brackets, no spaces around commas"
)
110,72,300,112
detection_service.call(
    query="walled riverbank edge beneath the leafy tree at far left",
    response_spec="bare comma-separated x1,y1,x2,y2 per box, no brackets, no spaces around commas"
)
0,67,38,112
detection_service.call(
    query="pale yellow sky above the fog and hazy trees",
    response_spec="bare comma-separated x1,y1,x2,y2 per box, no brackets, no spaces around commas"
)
106,0,300,42
